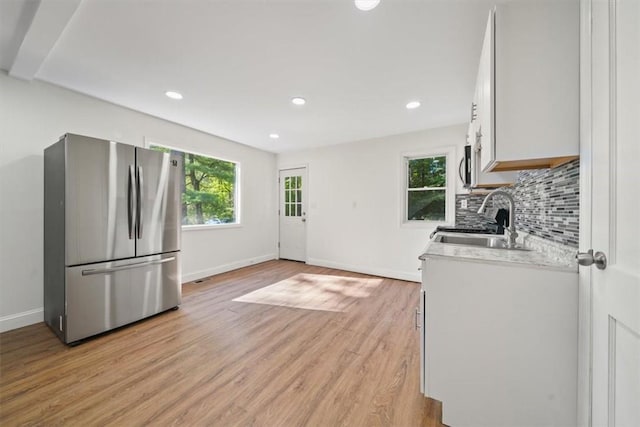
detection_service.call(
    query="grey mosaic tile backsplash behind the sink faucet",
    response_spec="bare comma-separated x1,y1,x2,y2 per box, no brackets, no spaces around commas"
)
456,160,580,248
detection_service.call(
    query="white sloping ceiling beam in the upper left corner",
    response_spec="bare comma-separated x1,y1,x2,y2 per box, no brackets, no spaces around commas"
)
9,0,82,80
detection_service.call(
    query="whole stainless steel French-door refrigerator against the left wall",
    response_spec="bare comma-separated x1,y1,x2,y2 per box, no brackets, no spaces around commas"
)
44,134,183,344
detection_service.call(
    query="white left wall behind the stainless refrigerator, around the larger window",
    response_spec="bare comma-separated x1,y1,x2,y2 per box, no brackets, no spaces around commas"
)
0,72,277,331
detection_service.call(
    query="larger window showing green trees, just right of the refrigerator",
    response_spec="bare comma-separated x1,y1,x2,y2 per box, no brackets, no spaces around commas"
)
150,145,239,225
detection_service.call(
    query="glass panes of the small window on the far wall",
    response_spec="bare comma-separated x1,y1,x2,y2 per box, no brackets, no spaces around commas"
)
405,155,447,221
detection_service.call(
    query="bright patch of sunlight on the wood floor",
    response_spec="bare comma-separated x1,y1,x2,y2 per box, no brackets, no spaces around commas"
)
233,273,382,312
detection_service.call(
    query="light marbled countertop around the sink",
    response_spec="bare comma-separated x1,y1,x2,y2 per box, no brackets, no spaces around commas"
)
419,232,578,273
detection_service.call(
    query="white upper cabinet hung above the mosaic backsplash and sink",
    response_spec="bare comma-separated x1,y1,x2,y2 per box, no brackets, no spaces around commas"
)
474,0,580,172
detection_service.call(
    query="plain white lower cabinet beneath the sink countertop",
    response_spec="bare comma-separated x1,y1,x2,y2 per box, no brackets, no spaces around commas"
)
421,257,578,427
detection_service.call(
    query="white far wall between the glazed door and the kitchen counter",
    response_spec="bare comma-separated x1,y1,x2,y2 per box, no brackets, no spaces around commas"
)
278,125,467,281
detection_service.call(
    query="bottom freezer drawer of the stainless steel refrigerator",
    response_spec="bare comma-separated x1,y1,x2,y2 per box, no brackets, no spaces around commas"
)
65,252,182,343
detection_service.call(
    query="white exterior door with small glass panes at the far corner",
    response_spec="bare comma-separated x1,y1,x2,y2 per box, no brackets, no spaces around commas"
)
279,168,307,262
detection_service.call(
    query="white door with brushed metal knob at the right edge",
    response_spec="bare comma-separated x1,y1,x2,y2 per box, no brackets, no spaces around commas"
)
581,0,640,427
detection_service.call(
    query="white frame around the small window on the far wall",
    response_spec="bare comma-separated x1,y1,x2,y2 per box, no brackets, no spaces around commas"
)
400,146,456,228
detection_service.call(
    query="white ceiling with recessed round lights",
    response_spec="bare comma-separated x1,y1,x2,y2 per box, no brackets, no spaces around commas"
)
0,0,493,152
